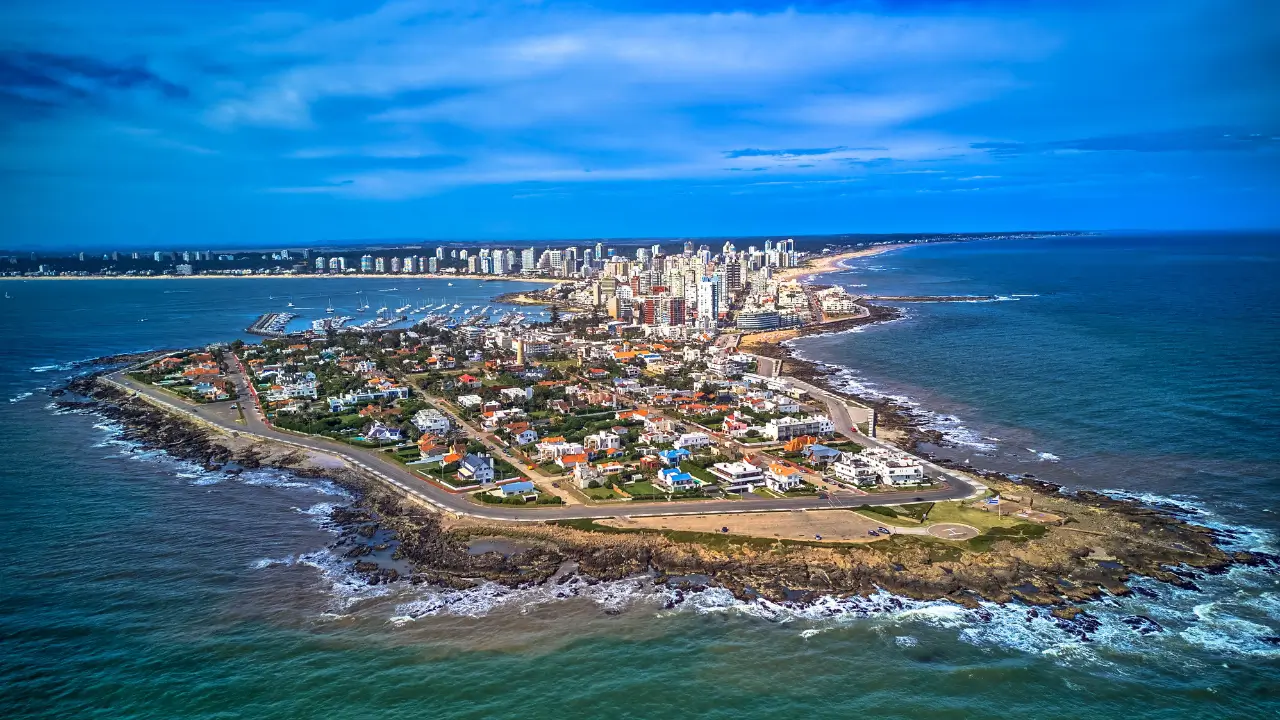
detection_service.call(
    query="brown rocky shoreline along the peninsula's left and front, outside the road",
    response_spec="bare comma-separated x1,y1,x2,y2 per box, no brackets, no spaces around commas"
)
47,363,1280,637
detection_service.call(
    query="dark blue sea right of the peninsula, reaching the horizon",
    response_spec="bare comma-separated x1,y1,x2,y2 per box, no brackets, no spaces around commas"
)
797,234,1280,525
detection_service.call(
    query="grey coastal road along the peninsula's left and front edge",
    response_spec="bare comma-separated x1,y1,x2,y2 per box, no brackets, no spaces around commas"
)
106,370,973,521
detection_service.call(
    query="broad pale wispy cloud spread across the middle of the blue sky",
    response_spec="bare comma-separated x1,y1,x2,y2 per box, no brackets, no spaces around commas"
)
206,1,1055,196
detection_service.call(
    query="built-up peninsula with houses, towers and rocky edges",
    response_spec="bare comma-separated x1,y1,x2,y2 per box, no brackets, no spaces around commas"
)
59,235,1276,627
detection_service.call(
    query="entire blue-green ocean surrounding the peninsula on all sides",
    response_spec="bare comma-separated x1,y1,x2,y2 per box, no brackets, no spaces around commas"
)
0,242,1280,719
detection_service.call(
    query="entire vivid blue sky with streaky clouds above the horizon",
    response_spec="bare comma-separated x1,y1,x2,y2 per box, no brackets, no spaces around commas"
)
0,0,1280,249
